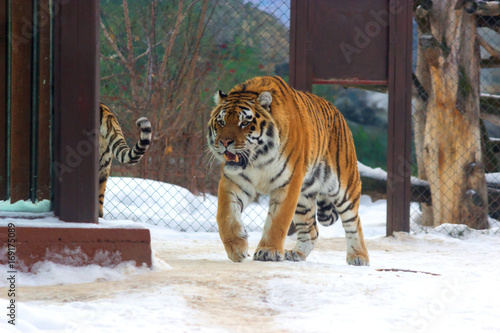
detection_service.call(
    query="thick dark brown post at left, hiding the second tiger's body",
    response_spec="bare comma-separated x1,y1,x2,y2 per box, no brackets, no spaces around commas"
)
53,0,99,223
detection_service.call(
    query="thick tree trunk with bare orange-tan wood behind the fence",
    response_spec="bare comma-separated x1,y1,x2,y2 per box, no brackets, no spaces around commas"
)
415,0,488,229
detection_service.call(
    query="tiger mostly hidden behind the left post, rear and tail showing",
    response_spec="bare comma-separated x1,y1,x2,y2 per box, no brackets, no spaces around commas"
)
98,102,151,217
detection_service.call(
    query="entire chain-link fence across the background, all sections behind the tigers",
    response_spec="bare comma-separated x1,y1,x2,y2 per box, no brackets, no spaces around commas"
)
101,0,500,236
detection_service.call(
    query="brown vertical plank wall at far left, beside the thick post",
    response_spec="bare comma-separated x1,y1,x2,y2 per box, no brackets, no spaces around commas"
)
0,0,52,203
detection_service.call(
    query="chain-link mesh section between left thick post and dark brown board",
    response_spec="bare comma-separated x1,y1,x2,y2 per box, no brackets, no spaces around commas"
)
101,0,290,231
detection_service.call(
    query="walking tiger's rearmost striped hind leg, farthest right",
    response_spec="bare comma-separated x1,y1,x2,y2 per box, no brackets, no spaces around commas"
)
336,191,370,266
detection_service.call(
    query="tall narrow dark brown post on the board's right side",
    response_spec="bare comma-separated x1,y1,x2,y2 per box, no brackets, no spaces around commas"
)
387,0,413,236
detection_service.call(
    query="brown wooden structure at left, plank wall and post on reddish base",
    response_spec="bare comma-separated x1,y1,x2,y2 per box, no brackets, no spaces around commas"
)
0,0,151,270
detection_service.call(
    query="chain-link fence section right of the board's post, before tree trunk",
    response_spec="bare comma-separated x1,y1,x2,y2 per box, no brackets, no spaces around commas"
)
411,0,500,237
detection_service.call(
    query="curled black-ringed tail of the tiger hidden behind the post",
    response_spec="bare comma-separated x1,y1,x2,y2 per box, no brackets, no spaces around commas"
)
101,112,151,165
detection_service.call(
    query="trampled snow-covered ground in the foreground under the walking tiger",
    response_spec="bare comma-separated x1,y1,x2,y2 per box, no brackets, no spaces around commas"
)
0,180,500,333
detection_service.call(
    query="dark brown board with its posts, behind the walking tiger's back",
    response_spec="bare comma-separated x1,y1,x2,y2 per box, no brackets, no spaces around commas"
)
290,0,413,235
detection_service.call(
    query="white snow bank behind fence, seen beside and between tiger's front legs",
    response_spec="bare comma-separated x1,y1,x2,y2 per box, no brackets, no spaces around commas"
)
104,177,268,232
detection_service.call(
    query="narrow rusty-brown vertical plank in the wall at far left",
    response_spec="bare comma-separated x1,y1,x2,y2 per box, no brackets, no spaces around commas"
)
10,1,33,203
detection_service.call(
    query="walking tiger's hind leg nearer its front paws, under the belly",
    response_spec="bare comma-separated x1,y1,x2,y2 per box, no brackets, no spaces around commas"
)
285,194,319,261
